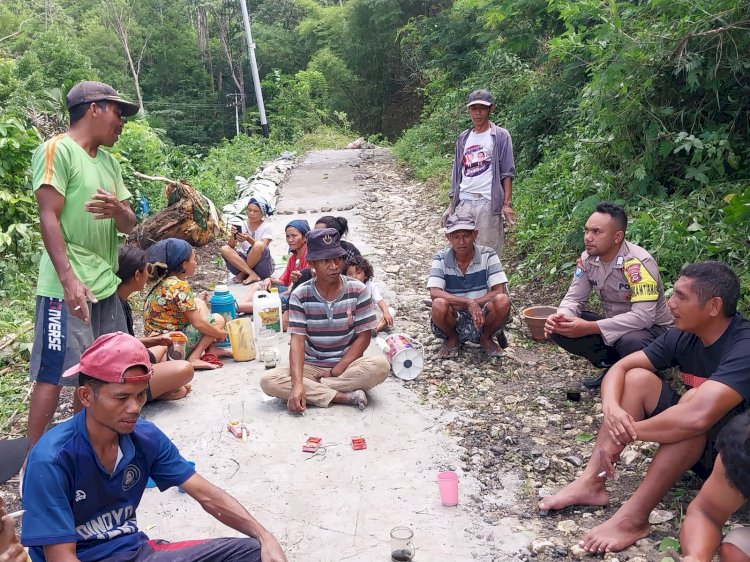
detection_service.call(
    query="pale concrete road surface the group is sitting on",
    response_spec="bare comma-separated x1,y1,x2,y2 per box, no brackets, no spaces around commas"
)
139,147,527,562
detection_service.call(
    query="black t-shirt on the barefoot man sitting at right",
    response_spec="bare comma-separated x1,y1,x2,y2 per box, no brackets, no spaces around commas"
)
643,312,750,400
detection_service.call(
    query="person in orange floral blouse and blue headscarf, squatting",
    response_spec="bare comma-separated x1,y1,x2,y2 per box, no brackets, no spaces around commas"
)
143,238,232,369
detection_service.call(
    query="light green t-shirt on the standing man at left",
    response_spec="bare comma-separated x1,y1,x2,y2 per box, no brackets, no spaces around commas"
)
31,134,130,299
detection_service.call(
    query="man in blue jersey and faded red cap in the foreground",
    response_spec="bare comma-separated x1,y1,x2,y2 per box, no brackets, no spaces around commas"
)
21,332,286,562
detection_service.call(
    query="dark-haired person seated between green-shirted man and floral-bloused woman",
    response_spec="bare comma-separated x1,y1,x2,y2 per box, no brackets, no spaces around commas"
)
117,246,193,402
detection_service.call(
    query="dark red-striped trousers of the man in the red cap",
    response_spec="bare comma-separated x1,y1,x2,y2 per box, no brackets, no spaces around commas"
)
100,539,260,562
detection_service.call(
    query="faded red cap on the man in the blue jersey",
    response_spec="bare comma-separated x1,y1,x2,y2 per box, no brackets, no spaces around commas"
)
63,332,152,383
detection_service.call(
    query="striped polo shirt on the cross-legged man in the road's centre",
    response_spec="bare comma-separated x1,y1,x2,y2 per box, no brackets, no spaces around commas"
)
289,275,378,367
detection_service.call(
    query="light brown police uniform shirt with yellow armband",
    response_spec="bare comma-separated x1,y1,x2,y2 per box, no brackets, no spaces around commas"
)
557,241,674,345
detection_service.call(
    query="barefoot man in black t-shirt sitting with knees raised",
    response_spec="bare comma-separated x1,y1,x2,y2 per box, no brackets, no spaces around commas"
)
539,262,750,552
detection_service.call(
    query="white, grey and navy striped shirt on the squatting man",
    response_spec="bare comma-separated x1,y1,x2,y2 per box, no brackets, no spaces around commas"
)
427,244,508,299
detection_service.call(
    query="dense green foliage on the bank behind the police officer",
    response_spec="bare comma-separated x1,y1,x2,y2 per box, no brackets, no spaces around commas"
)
395,0,750,312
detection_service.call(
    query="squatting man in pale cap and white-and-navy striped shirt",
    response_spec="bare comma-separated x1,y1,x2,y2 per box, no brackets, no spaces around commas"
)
427,211,510,359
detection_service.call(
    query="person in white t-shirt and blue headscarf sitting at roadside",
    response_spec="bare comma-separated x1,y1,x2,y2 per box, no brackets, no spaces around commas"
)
221,196,275,285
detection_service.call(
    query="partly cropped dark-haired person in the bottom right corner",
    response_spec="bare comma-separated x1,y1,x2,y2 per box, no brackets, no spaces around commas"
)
680,406,750,562
